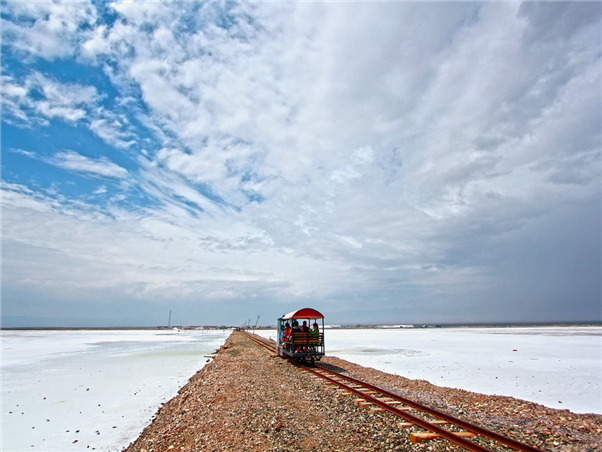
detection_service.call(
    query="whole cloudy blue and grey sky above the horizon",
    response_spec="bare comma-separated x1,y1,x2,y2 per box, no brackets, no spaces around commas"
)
0,1,602,327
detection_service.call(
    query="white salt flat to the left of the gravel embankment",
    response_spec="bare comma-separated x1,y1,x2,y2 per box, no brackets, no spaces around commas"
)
0,330,230,452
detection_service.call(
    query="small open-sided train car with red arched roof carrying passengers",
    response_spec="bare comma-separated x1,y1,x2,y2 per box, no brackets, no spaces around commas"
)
277,308,324,364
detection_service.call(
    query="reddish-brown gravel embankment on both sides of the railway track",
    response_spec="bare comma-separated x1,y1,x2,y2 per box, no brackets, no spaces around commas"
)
125,332,602,452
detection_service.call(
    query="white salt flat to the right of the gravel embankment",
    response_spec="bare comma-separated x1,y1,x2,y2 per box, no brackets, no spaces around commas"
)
258,327,602,414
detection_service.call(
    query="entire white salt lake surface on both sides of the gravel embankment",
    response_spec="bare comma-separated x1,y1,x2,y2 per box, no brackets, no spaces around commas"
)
0,327,602,452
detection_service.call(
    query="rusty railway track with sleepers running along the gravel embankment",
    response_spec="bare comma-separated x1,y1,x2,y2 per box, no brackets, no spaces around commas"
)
240,333,543,452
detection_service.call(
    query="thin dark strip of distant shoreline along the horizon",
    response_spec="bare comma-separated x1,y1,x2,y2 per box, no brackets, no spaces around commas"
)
0,322,602,332
